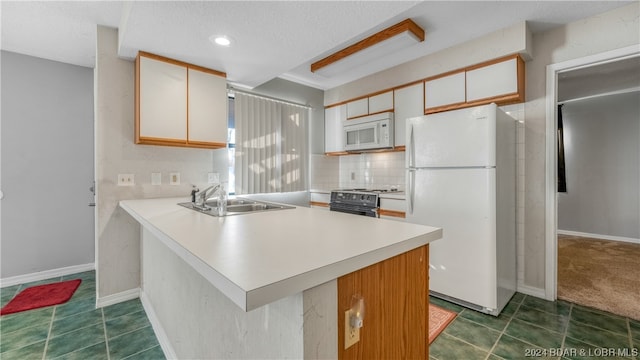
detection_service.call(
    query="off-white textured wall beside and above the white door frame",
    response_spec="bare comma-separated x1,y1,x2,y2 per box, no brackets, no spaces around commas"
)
523,2,640,289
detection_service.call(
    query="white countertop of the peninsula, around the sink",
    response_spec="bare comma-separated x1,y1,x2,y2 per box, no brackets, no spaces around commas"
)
120,196,442,311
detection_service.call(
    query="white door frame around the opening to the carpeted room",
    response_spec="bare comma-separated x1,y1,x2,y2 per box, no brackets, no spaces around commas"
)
545,45,640,301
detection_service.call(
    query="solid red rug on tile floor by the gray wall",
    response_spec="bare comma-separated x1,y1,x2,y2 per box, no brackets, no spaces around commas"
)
0,279,82,315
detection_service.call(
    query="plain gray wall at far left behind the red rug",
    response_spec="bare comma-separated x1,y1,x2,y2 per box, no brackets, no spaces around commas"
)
1,51,94,279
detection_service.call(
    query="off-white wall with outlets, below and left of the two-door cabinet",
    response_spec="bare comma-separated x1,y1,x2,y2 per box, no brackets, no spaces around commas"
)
95,26,215,303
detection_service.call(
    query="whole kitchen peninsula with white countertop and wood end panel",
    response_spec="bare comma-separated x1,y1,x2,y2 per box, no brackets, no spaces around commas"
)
120,198,442,359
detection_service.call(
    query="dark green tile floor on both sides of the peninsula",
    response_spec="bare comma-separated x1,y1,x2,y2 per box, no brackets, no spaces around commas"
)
0,271,640,360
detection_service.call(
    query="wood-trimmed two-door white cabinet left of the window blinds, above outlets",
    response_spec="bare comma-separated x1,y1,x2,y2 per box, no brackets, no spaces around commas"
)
135,51,228,149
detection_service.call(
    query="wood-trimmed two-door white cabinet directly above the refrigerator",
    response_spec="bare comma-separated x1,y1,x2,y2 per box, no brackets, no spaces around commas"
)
424,55,525,114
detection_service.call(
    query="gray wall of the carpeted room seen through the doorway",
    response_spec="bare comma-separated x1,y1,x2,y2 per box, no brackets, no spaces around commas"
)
558,92,640,239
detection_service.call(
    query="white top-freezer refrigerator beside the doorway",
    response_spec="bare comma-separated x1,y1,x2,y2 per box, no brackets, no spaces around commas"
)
405,104,516,316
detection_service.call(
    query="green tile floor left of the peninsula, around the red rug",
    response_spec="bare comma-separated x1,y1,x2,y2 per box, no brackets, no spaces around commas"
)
0,271,164,360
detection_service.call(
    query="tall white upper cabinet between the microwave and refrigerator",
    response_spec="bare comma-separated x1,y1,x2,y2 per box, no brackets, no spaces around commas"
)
394,83,424,147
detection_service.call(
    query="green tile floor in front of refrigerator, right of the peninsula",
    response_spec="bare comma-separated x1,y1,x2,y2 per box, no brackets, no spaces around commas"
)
429,293,640,360
